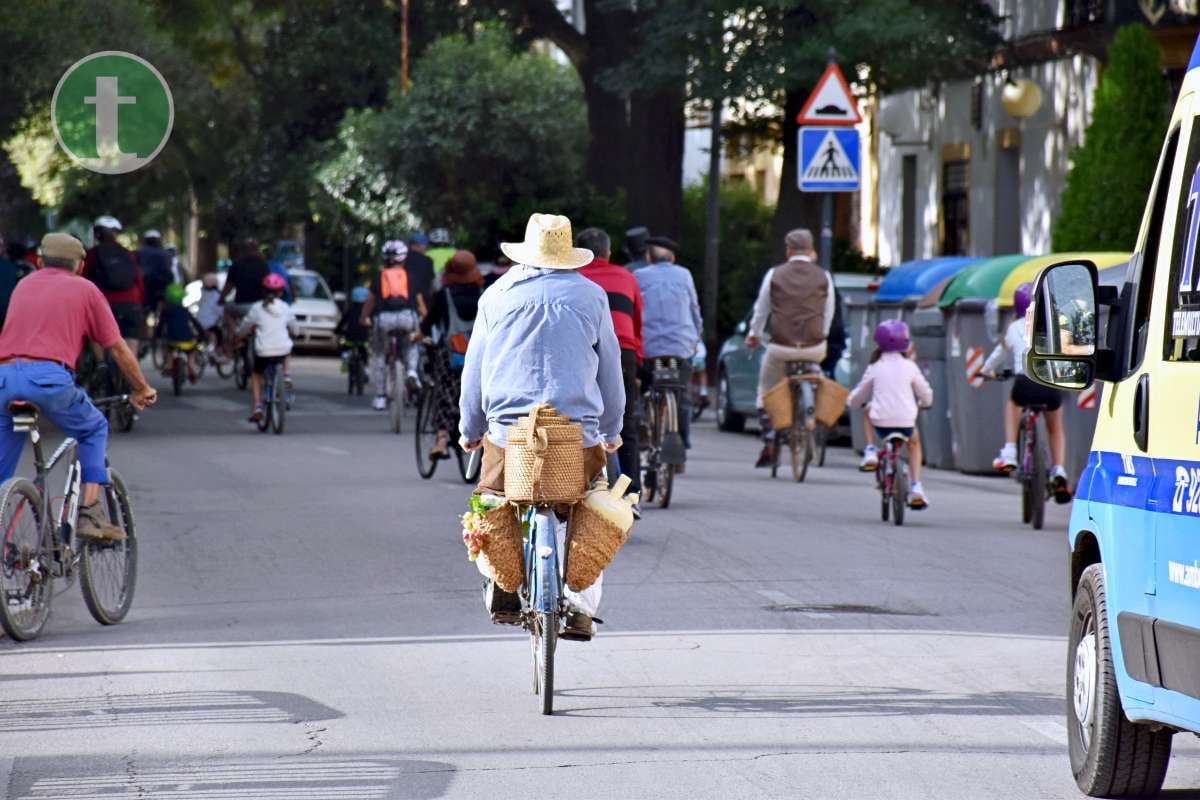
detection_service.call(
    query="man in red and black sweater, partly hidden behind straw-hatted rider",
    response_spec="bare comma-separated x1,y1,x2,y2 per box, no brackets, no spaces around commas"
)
575,228,642,510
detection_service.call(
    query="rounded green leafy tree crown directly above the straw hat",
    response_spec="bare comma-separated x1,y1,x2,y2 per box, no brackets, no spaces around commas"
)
343,29,590,249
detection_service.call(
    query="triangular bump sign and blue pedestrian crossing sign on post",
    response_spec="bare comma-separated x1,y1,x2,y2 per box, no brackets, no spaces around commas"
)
796,50,863,270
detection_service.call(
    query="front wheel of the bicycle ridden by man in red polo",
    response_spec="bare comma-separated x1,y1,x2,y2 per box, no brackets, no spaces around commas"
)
79,470,138,625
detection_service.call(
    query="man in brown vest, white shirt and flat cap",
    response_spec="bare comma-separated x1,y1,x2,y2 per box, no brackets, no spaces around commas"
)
746,228,835,468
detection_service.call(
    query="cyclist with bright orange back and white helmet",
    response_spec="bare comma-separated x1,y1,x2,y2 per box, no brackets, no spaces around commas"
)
361,240,420,411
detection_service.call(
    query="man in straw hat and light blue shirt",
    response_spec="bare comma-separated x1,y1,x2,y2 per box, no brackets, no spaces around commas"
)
460,213,625,639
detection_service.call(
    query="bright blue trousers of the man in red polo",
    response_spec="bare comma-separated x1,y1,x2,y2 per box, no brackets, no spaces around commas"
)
0,359,108,485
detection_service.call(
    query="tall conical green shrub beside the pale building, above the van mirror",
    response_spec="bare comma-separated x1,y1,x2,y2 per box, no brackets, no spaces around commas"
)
1052,25,1168,252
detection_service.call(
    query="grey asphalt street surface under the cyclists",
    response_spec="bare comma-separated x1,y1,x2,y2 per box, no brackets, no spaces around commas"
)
0,359,1200,800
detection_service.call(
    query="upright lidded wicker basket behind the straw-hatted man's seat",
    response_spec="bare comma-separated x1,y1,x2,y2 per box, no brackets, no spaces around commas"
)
504,403,587,504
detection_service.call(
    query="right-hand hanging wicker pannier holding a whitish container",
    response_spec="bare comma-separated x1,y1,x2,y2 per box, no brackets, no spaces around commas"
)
565,475,637,591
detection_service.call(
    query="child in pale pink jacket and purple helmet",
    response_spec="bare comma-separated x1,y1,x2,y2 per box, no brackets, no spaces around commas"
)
846,319,934,510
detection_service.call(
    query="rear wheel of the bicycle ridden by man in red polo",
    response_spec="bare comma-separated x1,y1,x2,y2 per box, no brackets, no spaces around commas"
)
0,477,54,642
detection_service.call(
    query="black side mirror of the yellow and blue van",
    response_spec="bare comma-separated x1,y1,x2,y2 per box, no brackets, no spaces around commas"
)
1025,261,1099,391
